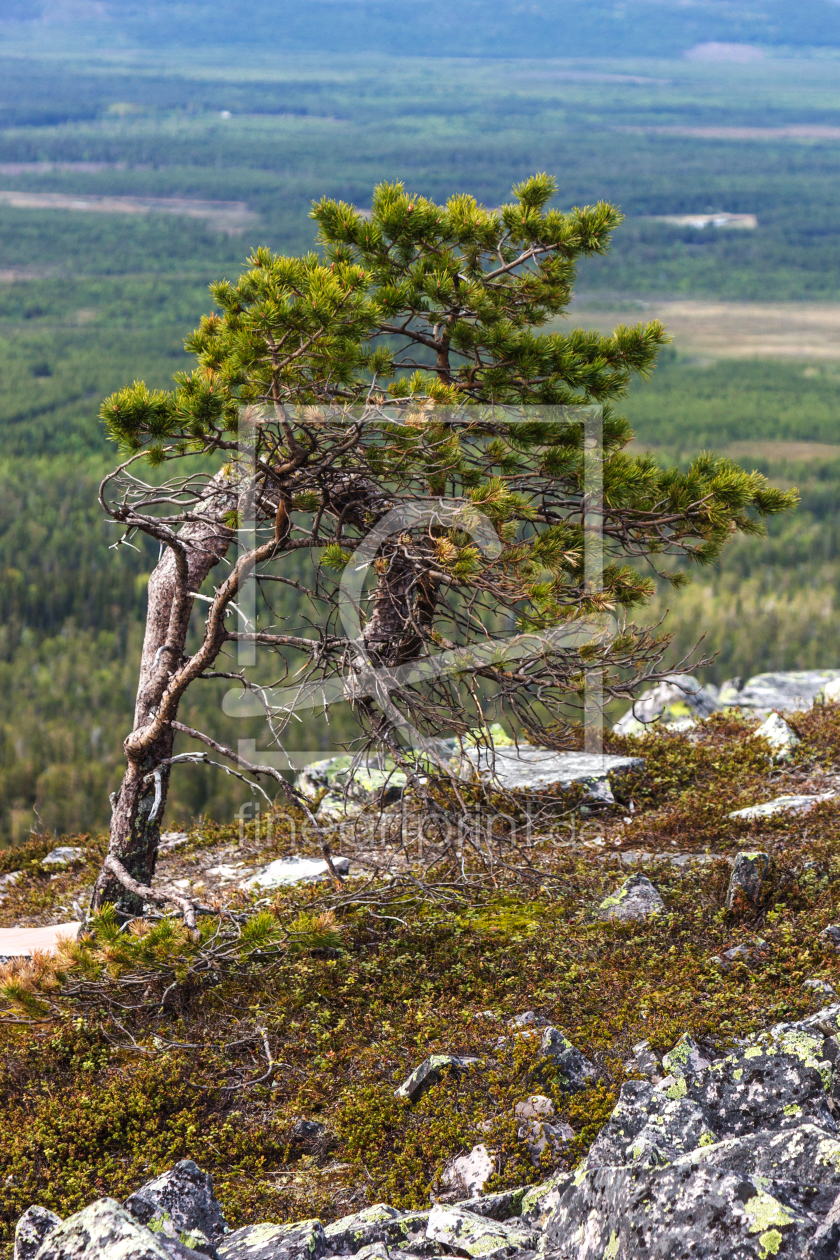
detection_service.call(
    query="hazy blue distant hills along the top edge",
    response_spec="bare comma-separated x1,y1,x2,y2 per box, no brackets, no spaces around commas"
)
4,0,840,58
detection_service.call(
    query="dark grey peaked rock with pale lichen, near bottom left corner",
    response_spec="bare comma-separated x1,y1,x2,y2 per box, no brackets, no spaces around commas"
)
125,1159,228,1255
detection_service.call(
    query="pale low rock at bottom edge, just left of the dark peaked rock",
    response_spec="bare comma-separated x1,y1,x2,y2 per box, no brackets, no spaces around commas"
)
29,1198,205,1260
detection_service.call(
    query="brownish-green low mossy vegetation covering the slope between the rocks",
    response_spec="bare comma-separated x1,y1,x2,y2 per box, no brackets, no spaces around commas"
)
0,706,840,1255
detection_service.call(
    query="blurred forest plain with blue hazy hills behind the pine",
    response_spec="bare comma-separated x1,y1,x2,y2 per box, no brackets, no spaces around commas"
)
0,0,840,843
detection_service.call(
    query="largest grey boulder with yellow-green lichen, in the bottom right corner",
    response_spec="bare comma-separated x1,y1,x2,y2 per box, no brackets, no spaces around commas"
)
541,1003,840,1260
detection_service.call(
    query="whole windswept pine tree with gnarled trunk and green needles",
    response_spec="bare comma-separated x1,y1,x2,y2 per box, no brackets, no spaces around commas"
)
94,175,795,920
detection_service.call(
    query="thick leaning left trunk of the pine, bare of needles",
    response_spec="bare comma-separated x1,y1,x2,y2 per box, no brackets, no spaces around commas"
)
92,473,236,919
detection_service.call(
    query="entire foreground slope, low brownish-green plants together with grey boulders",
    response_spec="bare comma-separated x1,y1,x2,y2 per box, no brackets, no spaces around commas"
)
0,685,840,1260
